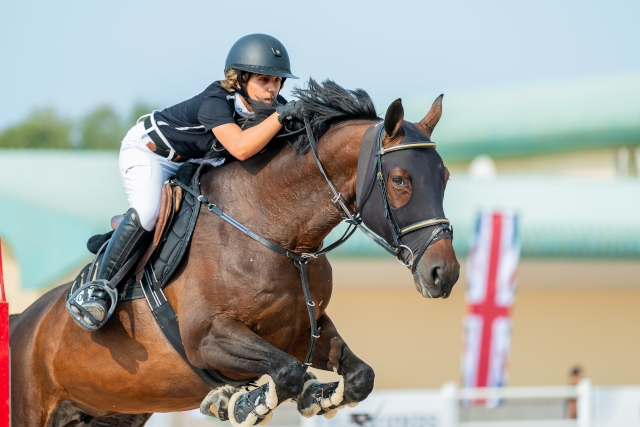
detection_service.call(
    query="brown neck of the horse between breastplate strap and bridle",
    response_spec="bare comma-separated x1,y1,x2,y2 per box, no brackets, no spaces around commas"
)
203,121,371,252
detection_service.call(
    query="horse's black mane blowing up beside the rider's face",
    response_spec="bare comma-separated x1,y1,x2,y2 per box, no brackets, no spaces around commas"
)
207,79,379,158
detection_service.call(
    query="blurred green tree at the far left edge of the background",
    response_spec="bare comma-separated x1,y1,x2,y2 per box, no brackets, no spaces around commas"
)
0,108,73,148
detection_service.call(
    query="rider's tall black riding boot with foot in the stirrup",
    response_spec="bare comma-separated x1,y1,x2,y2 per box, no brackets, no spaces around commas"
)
68,208,151,331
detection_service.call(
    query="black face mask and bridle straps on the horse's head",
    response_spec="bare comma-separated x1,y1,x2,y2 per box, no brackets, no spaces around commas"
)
356,122,453,271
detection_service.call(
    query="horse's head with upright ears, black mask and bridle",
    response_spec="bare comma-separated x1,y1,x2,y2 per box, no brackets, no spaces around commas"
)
356,95,460,298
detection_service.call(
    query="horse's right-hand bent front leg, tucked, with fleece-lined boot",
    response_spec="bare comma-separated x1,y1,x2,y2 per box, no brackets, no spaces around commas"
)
297,314,375,418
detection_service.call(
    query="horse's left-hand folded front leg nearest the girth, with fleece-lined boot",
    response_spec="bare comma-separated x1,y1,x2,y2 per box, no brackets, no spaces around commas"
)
184,315,304,427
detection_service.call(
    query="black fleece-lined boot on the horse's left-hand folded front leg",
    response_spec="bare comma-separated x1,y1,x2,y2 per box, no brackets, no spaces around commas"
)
229,379,278,427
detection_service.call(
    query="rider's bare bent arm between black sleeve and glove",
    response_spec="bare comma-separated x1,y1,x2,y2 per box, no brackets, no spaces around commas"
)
211,113,282,160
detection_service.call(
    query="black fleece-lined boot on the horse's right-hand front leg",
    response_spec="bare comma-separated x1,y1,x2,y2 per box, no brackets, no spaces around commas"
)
297,379,344,418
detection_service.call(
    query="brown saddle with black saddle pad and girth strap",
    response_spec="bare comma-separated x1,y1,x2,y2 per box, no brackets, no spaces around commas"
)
67,162,256,388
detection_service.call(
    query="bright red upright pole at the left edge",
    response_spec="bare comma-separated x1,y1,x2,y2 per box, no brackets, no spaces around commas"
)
0,240,11,427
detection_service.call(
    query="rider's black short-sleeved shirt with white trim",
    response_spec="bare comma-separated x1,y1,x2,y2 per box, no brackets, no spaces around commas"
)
154,82,286,159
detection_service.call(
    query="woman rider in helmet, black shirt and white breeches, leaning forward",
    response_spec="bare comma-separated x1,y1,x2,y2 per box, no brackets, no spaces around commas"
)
69,34,302,330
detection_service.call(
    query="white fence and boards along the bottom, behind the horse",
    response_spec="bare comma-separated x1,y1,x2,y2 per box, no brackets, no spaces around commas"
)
148,380,640,427
